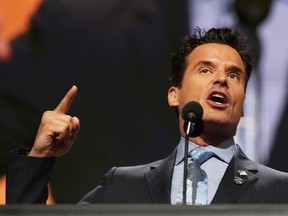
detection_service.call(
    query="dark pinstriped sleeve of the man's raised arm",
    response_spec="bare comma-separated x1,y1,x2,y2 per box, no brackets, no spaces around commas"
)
6,149,55,204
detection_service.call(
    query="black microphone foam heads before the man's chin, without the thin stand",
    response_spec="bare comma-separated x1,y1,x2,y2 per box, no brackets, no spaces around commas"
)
182,101,204,137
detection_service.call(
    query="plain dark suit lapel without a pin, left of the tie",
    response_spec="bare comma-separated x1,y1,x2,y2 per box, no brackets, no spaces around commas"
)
145,148,177,204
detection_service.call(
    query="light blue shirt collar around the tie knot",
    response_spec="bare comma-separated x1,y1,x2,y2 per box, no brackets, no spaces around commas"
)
175,136,236,165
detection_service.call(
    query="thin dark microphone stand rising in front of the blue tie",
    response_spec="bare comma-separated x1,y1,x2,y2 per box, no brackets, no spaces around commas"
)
182,121,194,205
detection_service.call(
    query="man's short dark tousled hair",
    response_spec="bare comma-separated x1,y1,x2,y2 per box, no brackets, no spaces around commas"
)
170,27,254,89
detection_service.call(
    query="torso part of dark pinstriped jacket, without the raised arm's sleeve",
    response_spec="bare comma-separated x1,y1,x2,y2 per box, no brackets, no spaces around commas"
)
80,148,288,204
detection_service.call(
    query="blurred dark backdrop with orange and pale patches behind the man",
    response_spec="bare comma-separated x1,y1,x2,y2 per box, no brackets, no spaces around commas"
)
0,0,288,203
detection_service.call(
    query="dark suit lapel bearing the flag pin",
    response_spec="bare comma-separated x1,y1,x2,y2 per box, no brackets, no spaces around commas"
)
211,147,258,204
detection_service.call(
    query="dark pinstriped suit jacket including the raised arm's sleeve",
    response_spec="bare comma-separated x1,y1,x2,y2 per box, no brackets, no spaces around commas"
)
7,148,288,204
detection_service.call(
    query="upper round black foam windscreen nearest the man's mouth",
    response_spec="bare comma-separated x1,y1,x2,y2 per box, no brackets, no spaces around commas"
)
182,101,203,121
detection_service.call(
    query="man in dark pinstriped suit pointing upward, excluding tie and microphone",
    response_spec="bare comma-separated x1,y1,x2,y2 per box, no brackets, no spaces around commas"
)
7,28,288,204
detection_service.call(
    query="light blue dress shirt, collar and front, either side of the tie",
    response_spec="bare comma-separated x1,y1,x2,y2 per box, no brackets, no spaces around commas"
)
171,137,237,205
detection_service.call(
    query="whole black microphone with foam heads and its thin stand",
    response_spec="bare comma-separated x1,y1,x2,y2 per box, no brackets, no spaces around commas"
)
182,101,204,205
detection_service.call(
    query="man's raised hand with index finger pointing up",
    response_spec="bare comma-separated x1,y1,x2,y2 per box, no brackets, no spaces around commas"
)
29,86,80,157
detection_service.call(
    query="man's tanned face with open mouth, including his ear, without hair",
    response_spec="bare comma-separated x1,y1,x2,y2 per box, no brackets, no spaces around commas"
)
168,43,245,137
